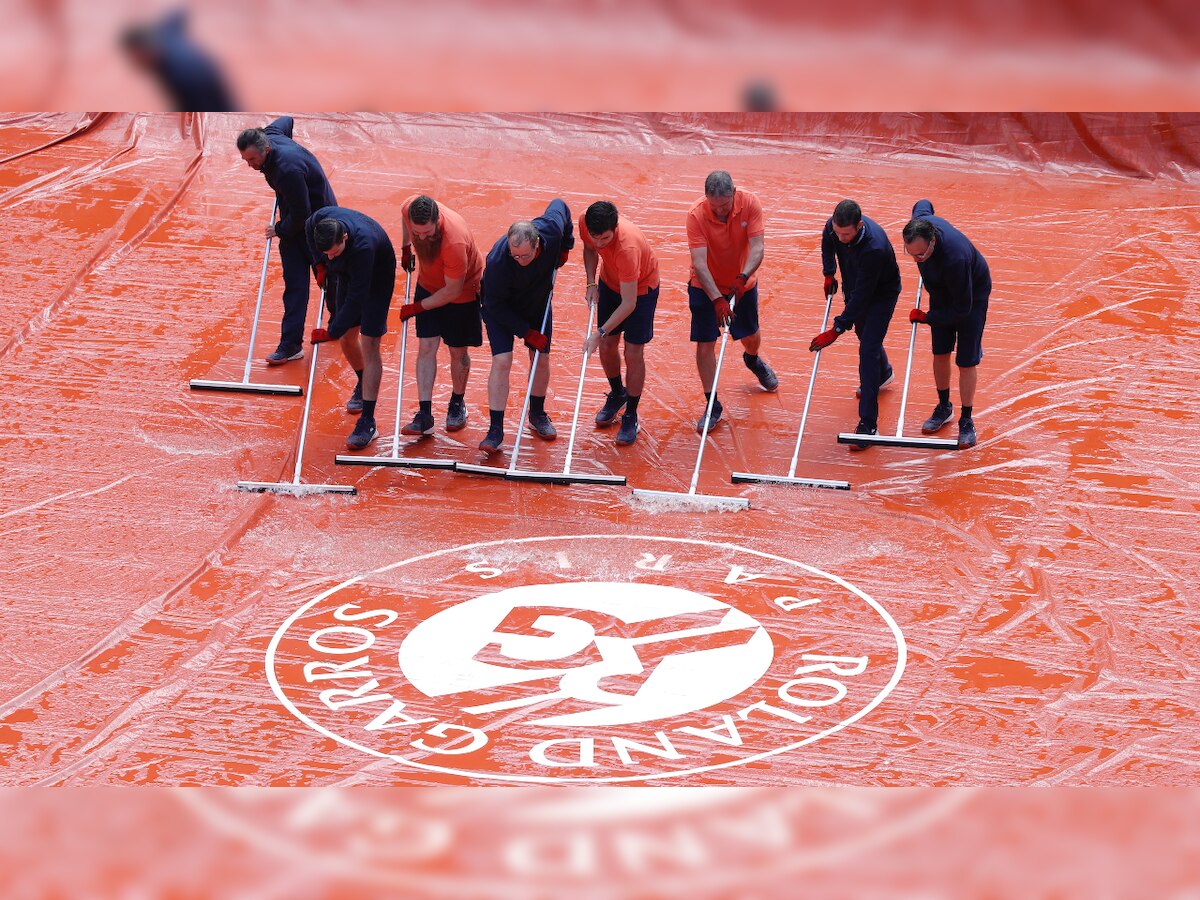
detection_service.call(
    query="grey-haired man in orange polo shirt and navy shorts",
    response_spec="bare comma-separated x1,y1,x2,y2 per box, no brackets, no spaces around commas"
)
688,170,779,433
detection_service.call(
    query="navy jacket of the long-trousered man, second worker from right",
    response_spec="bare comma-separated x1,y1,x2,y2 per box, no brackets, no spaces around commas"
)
821,216,900,331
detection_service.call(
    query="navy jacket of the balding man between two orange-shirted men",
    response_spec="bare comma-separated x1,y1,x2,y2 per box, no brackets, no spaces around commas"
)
481,198,575,336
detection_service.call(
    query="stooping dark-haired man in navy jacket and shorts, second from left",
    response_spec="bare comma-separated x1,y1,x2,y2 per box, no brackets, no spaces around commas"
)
305,206,396,450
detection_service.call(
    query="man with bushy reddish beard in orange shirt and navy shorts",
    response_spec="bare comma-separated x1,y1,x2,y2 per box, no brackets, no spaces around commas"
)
400,194,484,436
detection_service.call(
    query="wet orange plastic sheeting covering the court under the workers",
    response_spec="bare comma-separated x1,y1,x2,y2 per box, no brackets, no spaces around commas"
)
0,115,1200,786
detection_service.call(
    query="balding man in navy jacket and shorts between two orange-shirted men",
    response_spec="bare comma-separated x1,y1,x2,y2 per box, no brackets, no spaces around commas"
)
479,198,575,454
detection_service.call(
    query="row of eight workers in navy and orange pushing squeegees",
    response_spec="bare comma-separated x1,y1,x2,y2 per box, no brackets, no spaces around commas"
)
236,116,991,454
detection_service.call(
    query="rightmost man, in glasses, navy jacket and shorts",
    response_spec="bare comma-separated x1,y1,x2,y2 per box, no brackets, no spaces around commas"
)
902,200,991,450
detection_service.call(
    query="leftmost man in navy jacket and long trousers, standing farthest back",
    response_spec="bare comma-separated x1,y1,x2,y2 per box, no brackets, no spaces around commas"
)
238,115,338,376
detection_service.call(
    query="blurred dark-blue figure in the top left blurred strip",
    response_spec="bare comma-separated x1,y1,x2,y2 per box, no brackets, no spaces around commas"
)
121,10,234,111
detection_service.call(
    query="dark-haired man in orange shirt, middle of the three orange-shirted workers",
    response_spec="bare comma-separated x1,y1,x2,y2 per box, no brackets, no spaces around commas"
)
580,200,659,446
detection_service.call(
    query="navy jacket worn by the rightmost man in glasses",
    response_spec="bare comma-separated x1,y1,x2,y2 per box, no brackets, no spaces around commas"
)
912,200,991,325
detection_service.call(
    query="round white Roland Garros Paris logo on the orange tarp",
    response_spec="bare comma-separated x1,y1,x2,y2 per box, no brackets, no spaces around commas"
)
266,535,905,784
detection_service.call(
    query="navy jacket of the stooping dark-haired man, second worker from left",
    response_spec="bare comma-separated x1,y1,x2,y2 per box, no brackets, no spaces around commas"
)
305,206,396,340
